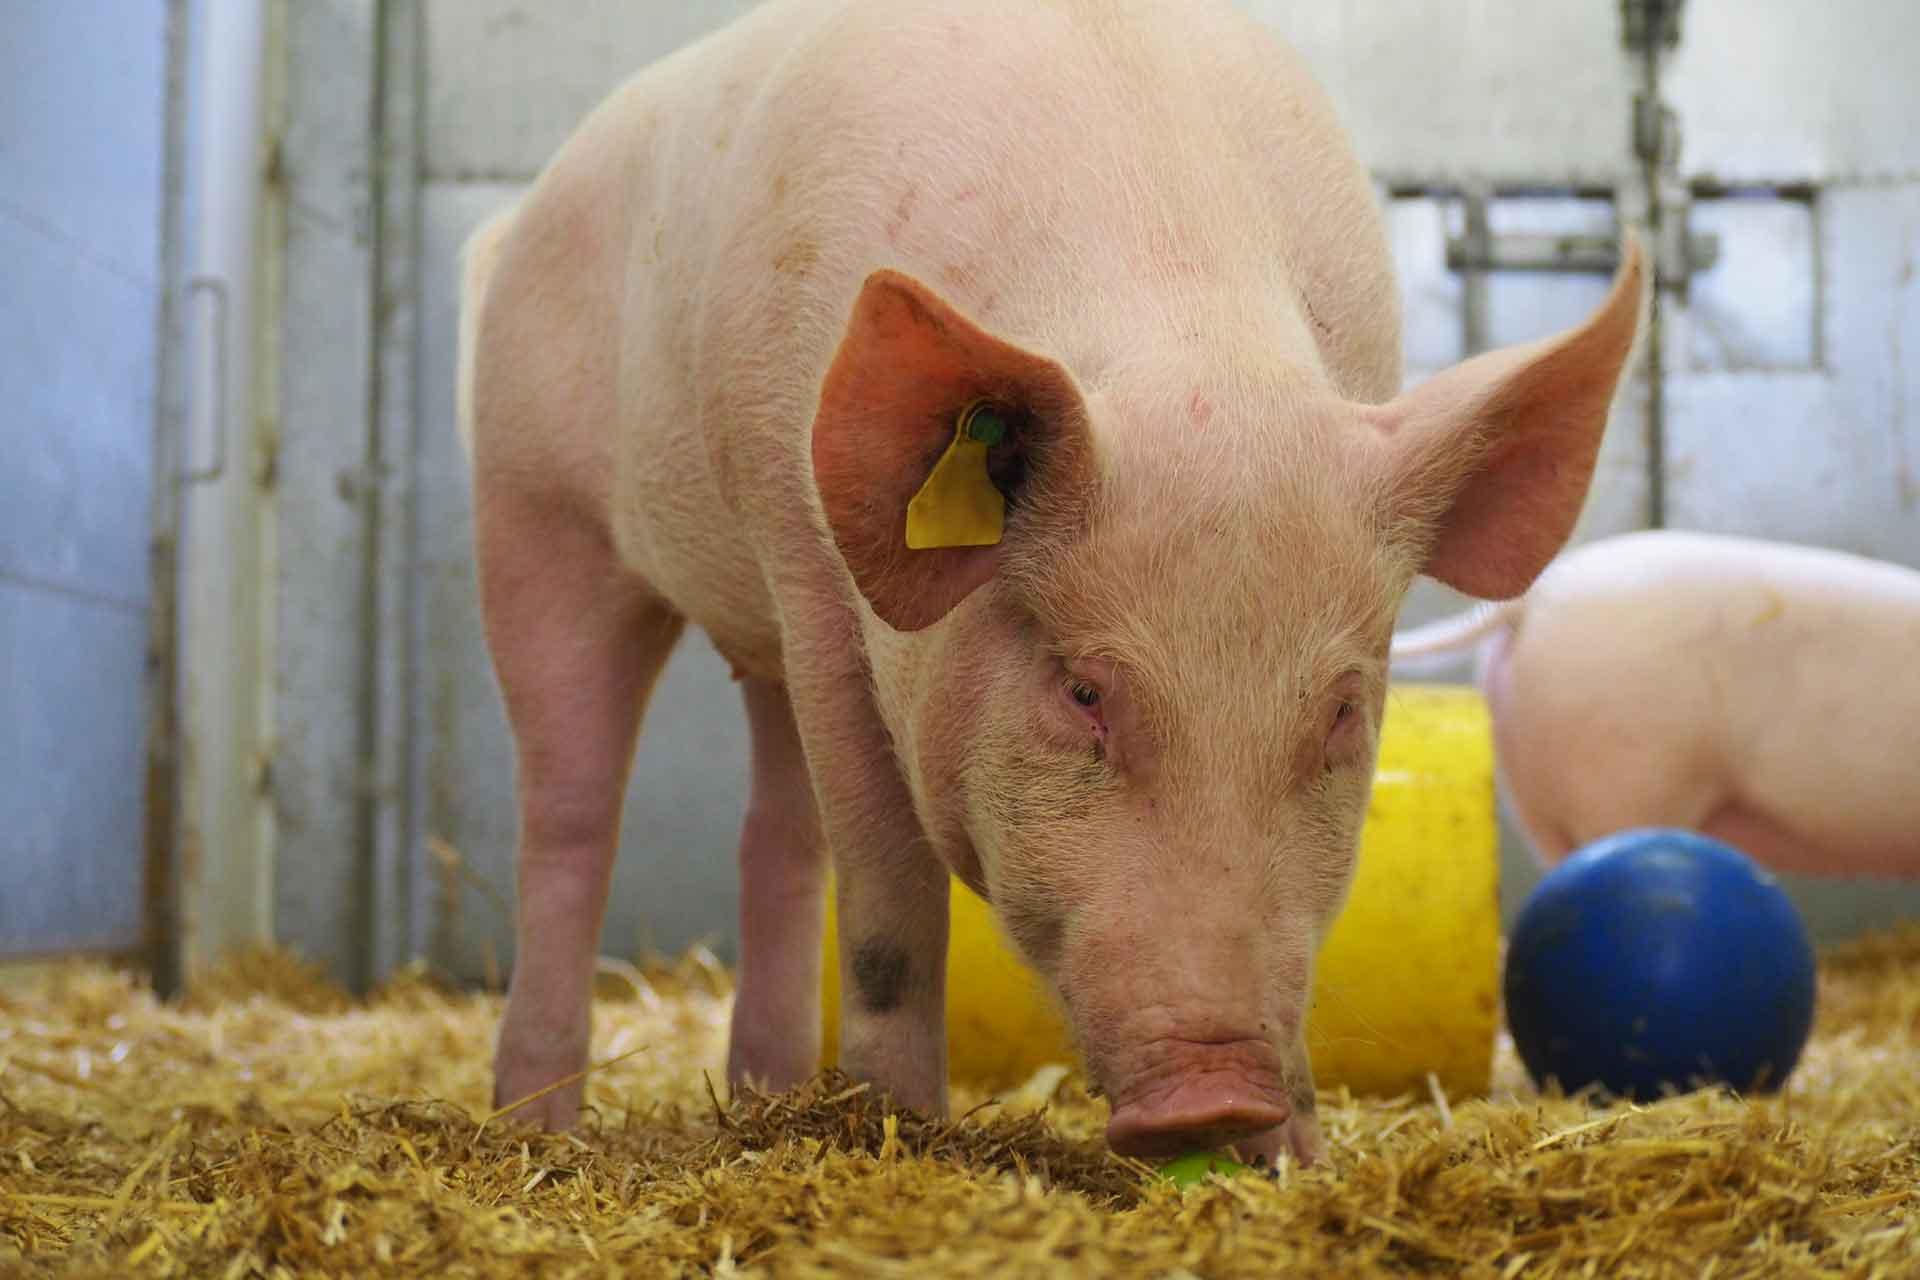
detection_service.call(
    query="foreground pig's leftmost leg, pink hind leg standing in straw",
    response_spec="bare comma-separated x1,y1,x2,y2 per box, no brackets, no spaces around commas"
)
476,491,684,1128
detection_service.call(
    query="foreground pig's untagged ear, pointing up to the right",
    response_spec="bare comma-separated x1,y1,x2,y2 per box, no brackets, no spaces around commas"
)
1367,236,1645,599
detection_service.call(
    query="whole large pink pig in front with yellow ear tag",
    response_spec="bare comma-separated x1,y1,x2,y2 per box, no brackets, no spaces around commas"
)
461,0,1644,1161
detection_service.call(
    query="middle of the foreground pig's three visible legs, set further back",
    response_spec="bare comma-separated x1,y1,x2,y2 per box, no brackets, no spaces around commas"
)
728,677,826,1088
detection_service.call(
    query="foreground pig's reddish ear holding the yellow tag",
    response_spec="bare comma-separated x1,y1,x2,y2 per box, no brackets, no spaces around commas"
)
812,271,1089,631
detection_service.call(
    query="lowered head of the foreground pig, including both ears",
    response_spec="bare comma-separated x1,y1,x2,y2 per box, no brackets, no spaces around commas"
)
812,248,1642,1159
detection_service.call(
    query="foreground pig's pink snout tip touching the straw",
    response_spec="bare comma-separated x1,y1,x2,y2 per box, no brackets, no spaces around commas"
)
1106,1038,1294,1161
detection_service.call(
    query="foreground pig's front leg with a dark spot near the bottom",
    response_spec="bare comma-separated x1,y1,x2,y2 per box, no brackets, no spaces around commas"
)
787,604,948,1115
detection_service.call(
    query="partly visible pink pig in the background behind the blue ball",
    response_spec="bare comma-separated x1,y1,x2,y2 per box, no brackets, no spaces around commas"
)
1392,530,1920,879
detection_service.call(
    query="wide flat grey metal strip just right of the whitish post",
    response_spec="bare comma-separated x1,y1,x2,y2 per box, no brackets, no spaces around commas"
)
263,0,380,986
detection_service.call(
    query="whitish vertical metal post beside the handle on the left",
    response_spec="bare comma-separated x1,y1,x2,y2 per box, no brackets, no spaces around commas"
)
167,0,273,977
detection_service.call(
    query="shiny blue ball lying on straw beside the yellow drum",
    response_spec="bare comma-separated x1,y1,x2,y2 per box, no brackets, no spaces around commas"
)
1505,827,1814,1098
